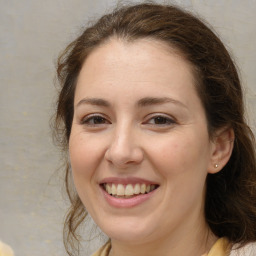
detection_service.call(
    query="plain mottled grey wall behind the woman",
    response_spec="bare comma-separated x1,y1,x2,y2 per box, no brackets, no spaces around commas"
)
0,0,256,256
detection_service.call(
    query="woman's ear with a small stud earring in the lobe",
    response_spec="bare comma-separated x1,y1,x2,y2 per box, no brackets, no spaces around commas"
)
208,127,235,174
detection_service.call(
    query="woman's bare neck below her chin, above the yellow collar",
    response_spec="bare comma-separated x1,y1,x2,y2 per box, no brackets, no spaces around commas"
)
109,222,217,256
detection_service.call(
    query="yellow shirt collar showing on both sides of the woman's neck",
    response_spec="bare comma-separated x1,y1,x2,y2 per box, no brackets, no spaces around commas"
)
92,238,230,256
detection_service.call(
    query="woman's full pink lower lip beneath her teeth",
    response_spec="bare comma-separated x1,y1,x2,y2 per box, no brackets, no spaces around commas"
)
101,188,157,208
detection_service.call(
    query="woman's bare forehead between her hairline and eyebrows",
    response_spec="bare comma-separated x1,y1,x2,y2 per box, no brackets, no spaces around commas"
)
76,38,200,105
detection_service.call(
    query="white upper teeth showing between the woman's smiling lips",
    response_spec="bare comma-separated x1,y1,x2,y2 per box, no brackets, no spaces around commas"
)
101,183,159,198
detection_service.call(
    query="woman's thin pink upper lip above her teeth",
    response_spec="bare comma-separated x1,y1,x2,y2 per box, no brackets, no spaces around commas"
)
99,177,158,185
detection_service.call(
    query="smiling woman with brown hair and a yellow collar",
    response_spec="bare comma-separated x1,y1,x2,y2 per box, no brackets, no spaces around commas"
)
53,4,256,256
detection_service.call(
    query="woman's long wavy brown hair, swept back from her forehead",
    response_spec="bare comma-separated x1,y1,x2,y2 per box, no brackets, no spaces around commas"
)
55,3,256,255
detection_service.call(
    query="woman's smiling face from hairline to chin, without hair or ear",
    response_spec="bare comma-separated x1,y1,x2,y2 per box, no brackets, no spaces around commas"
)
69,39,214,243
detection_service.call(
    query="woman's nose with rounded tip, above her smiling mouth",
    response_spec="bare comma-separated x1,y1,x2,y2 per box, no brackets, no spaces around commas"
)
105,125,144,169
